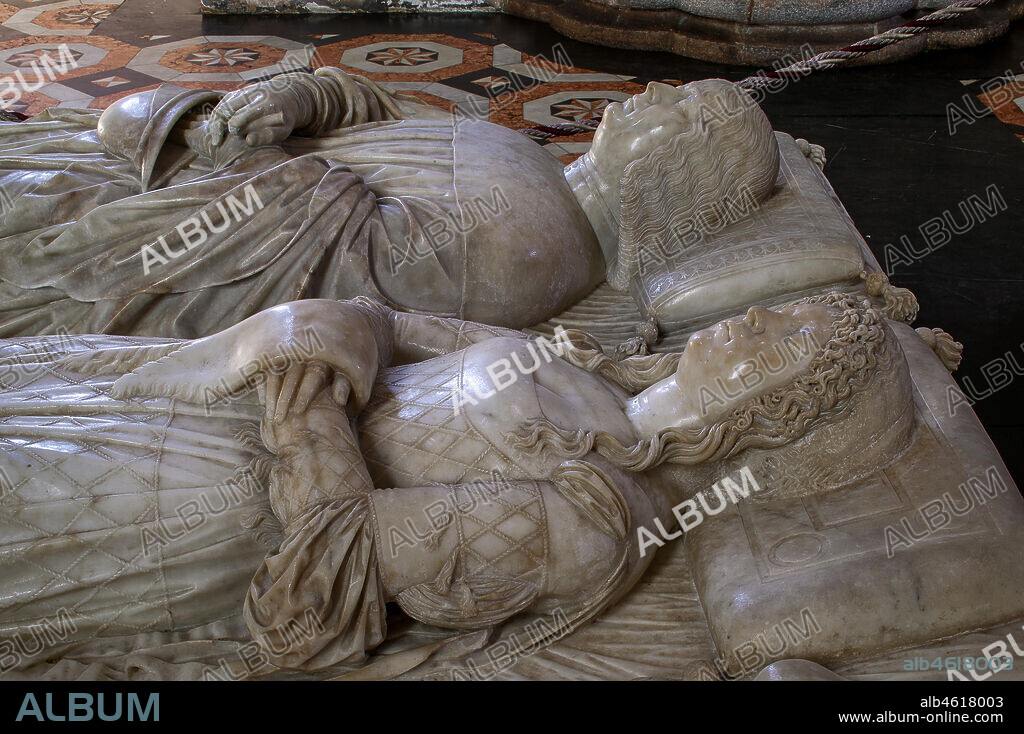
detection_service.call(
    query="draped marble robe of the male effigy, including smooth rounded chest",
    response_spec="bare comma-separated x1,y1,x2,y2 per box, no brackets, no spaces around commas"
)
0,70,603,338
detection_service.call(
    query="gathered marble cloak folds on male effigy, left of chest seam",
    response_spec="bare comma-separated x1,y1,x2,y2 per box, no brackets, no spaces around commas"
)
0,110,464,338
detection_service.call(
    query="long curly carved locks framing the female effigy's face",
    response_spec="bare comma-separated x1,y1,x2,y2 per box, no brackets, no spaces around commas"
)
507,294,898,472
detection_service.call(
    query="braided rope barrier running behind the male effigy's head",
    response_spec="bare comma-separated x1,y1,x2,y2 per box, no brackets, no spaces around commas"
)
519,0,998,143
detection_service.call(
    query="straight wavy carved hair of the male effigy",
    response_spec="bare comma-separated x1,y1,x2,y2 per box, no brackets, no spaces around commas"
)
607,79,779,291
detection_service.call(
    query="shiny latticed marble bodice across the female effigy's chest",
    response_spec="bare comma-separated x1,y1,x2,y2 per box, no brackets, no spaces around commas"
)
358,338,635,487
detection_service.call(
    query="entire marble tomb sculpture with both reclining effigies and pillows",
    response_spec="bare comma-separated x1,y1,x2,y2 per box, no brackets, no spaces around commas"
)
0,70,1024,680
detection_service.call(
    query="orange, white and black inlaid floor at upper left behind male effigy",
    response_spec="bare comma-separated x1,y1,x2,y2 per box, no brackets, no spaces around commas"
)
0,0,680,162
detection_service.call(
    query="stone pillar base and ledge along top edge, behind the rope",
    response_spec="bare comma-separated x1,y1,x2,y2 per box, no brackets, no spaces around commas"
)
202,0,1024,66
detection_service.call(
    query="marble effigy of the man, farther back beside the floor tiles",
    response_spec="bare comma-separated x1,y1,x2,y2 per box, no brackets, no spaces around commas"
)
0,73,779,338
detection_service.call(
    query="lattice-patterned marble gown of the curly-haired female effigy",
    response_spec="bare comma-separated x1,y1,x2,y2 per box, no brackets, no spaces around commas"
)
0,311,664,678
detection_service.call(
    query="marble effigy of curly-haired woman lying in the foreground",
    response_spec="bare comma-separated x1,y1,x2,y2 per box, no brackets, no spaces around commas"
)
0,294,913,678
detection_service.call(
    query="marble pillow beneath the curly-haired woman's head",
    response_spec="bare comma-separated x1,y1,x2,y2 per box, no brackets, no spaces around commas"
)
686,322,1024,671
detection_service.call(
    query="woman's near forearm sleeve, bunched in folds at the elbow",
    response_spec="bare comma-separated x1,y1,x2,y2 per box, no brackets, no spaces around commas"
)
244,395,386,671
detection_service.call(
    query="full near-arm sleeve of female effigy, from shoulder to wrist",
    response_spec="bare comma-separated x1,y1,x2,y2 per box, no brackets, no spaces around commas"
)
244,395,649,671
